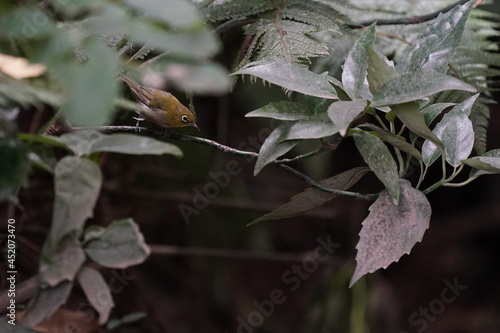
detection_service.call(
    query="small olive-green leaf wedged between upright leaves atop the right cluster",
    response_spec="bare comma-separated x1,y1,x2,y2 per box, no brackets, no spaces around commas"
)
366,46,399,94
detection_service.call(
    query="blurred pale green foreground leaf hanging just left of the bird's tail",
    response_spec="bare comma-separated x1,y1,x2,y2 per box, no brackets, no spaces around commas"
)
55,38,118,126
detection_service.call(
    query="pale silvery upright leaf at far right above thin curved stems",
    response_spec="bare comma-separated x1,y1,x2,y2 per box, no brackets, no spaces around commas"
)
422,94,478,167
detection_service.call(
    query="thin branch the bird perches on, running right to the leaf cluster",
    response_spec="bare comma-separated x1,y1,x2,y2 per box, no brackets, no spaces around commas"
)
73,126,377,201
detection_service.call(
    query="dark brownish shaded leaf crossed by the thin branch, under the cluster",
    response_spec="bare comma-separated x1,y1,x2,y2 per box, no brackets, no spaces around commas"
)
247,167,370,226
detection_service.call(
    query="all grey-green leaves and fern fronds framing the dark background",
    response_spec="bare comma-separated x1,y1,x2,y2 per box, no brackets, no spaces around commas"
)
0,0,500,330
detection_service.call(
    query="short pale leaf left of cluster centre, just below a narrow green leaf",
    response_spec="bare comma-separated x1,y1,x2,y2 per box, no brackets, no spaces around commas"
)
281,113,339,141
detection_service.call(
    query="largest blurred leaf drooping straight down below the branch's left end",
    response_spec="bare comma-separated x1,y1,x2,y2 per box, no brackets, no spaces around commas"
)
47,156,102,247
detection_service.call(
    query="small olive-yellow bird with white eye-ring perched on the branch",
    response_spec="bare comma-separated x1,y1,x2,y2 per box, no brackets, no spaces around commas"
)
118,73,200,130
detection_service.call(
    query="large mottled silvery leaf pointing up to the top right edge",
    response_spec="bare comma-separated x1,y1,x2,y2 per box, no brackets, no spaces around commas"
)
398,1,473,73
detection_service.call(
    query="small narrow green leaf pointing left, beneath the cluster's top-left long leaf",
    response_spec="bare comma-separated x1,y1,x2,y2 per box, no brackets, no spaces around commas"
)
245,101,311,120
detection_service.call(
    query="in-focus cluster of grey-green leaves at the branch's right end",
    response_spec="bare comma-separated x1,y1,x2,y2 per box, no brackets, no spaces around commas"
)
235,3,497,285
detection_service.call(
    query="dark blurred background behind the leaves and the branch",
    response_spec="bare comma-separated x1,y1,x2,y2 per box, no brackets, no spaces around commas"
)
2,2,500,333
